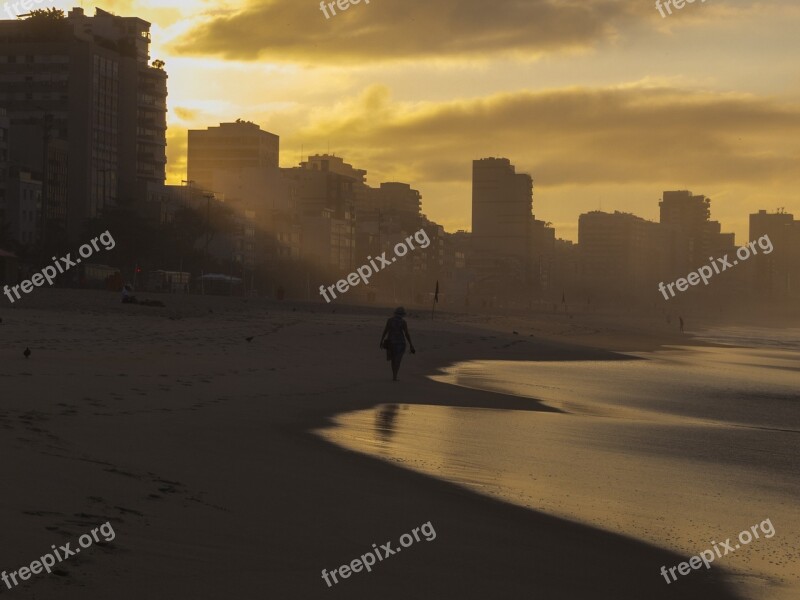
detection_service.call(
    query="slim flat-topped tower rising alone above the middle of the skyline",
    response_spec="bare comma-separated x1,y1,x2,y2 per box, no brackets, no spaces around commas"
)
472,158,533,283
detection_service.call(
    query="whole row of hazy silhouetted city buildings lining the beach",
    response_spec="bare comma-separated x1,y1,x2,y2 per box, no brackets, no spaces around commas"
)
0,8,797,308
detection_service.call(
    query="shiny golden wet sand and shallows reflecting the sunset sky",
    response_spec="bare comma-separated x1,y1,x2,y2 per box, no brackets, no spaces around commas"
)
321,348,800,600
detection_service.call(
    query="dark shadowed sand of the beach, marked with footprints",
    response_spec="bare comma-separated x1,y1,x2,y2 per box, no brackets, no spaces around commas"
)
0,289,797,600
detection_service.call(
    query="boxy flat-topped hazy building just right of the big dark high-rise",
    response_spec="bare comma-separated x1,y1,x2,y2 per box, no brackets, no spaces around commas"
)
187,120,280,193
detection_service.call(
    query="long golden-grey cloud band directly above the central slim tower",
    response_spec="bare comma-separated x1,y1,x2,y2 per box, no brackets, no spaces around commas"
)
284,85,800,186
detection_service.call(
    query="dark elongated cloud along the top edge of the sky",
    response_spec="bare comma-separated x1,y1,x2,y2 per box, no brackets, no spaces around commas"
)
172,0,653,64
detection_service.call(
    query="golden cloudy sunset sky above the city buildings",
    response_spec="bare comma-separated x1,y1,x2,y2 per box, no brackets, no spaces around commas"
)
36,0,800,244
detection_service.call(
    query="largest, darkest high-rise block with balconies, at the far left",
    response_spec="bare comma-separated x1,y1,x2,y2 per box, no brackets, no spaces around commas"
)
0,8,167,239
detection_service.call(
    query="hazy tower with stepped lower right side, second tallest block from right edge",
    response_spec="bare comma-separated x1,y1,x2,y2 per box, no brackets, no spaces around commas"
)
659,190,734,274
